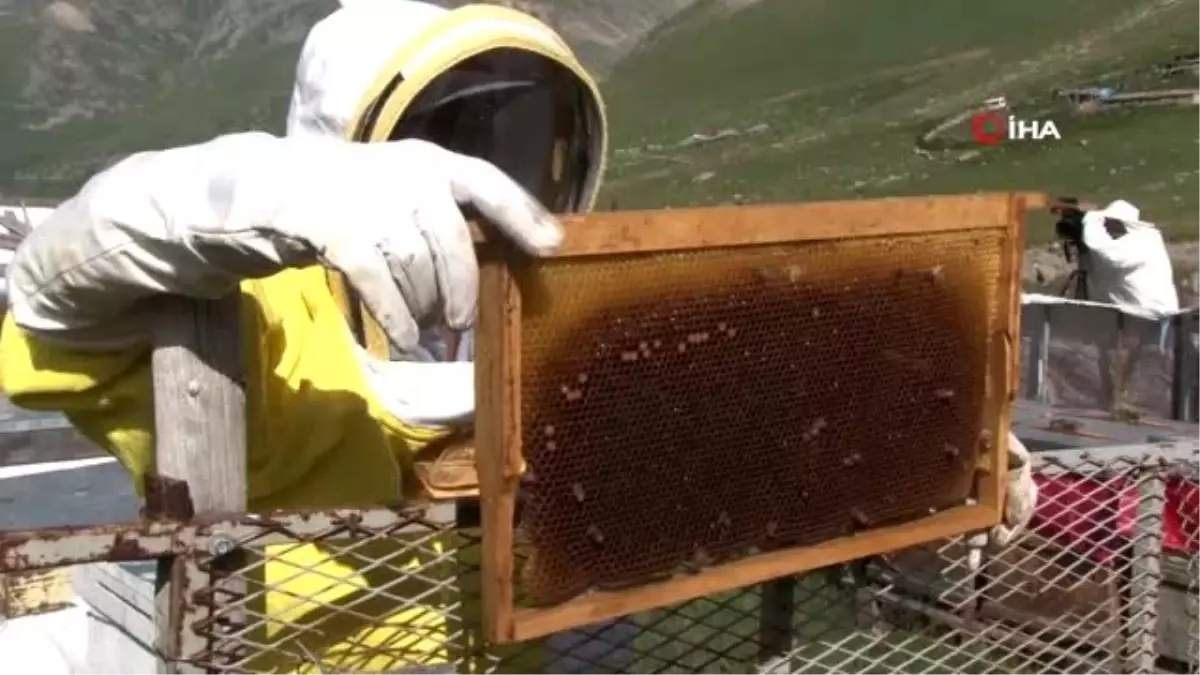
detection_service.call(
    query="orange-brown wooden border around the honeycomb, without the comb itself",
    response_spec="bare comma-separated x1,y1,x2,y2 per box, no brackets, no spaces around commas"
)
475,192,1046,644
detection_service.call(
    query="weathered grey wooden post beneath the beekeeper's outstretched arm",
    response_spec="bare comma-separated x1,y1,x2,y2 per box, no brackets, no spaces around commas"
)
146,292,246,674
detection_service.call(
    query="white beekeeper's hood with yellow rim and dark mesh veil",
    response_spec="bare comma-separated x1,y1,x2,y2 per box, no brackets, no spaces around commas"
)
288,0,606,213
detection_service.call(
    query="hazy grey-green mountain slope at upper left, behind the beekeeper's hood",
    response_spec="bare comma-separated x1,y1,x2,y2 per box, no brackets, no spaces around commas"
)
0,0,692,197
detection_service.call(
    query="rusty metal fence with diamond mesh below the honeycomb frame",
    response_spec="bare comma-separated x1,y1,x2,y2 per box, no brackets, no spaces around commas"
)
0,440,1200,675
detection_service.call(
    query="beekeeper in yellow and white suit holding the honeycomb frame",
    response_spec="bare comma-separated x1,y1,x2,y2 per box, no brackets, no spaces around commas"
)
0,0,606,671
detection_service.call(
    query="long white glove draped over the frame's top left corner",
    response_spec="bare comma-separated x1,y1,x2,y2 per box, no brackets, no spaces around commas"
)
8,132,563,356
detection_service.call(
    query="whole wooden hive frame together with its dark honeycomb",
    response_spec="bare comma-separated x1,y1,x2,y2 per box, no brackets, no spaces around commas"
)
475,195,1027,643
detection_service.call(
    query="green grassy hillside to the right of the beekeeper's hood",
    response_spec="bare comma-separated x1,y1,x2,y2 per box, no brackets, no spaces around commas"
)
606,0,1200,243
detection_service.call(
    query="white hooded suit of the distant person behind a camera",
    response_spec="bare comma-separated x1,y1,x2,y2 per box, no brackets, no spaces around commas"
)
1084,199,1180,316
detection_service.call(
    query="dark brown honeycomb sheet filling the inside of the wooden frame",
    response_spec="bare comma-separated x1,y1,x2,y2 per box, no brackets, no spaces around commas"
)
517,231,1004,605
